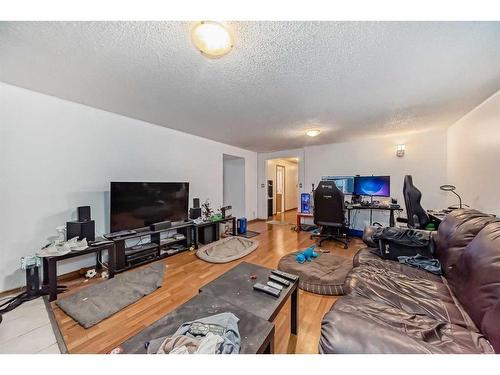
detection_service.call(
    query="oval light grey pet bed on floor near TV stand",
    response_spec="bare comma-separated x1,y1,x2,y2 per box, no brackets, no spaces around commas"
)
196,237,259,263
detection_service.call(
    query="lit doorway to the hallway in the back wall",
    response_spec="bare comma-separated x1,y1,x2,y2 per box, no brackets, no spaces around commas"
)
266,157,299,217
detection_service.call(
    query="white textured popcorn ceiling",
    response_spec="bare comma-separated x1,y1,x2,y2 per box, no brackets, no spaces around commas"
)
0,22,500,151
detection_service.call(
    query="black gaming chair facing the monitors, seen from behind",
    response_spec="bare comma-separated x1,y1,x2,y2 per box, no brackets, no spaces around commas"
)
311,181,349,249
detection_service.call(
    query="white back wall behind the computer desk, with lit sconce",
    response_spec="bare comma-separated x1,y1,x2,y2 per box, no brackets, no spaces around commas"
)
305,129,447,209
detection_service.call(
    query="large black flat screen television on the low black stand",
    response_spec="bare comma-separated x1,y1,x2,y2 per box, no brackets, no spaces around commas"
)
110,182,189,232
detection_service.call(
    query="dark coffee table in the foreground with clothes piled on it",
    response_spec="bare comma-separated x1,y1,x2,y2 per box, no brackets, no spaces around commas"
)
120,293,274,354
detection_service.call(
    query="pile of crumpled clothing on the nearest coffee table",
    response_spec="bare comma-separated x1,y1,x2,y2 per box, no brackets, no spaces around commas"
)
147,313,241,354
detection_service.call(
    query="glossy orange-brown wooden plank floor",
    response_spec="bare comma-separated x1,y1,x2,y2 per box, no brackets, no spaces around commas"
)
52,211,362,353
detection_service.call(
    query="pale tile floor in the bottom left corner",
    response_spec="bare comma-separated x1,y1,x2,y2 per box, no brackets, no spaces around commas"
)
0,297,60,354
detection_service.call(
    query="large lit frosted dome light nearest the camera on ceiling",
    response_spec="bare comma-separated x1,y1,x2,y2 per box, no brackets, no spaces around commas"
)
191,21,233,58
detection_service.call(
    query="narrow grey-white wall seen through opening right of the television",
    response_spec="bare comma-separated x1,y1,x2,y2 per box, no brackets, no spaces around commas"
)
223,155,246,218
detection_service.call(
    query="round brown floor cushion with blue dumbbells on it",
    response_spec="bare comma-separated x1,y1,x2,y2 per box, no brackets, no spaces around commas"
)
278,252,352,296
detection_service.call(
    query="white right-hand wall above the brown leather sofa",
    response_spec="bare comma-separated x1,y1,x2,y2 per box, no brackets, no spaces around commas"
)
447,91,500,216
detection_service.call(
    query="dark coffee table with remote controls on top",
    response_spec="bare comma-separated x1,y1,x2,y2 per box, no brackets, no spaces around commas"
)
200,262,299,335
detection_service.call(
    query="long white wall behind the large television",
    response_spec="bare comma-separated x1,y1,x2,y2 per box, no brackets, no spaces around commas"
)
0,83,257,291
